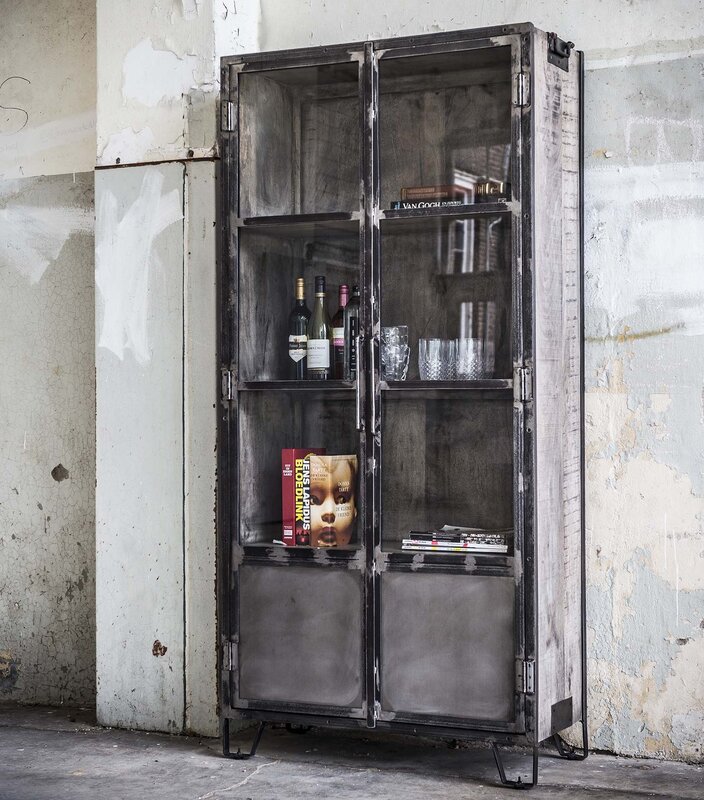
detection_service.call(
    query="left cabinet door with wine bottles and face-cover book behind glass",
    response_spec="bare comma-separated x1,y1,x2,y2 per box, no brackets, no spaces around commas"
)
230,54,367,718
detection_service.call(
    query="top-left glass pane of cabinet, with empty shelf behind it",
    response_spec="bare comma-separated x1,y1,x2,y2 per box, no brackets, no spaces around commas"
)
239,61,361,217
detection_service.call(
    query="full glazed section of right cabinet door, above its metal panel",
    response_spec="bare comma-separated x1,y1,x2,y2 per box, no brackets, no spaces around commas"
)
378,44,514,553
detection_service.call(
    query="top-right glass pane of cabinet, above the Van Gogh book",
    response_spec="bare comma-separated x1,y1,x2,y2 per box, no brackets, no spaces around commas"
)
379,47,511,208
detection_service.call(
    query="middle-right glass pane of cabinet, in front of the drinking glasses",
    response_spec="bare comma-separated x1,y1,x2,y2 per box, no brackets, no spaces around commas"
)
381,215,512,380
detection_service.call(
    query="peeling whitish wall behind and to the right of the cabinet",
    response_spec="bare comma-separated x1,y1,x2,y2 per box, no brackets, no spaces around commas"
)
261,0,704,762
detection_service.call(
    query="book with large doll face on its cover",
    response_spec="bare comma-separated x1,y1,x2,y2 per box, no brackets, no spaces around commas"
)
310,455,357,547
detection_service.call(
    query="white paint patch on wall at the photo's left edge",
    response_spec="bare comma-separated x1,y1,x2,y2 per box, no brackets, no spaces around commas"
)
0,205,93,284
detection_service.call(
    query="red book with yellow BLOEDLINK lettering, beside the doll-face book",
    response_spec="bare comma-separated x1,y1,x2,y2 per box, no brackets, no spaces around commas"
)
281,447,325,547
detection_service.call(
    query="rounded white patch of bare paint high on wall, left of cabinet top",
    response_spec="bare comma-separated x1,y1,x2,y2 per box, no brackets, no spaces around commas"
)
122,39,200,106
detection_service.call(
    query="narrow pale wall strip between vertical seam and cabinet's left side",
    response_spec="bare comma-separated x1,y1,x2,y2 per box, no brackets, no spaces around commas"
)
184,162,218,736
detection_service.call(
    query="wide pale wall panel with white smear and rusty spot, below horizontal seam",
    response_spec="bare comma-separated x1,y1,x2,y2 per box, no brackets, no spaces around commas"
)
96,164,184,731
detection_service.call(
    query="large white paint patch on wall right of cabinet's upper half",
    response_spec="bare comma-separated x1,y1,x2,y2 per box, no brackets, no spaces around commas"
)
585,161,704,336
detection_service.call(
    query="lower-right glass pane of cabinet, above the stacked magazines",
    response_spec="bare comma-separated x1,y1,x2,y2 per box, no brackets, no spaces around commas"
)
381,392,513,554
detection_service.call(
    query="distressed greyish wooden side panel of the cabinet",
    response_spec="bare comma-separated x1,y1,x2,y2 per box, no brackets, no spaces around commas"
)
532,33,582,740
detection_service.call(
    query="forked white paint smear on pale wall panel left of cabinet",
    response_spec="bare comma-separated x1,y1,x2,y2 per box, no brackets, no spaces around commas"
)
95,168,183,364
